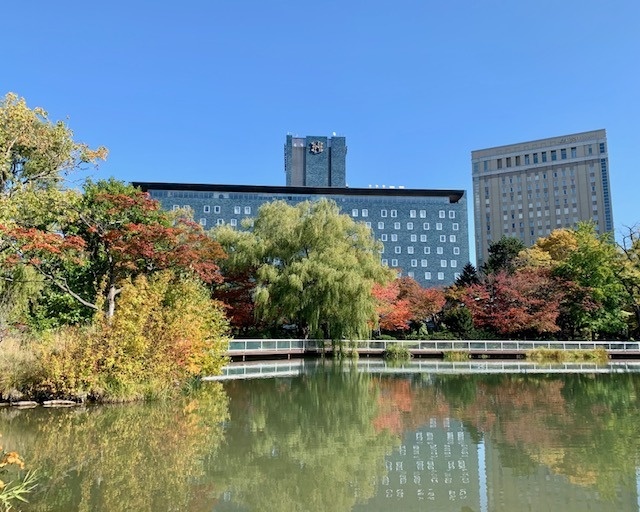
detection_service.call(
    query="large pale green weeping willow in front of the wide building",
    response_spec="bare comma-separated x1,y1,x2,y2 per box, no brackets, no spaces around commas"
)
214,199,393,340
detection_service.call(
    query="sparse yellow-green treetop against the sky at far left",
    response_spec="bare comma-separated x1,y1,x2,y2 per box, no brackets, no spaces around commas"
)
0,93,107,197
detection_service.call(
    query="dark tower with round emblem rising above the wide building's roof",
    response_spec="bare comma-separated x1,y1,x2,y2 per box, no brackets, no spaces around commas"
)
284,135,347,188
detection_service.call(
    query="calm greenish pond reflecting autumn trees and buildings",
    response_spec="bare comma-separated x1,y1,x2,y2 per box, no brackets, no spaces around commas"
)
0,361,640,512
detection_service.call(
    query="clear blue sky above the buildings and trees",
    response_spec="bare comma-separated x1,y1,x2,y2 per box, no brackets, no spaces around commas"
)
5,0,640,260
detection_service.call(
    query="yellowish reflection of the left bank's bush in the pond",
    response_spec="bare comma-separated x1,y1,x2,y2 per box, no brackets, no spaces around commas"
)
0,384,228,512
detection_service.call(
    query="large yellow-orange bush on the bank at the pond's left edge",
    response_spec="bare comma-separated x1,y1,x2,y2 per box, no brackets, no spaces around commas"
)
4,272,228,401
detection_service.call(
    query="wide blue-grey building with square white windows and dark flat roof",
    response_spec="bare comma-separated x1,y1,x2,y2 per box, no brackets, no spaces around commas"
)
133,182,469,287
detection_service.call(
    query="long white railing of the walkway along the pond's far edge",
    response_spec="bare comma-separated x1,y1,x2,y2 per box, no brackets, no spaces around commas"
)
228,339,640,356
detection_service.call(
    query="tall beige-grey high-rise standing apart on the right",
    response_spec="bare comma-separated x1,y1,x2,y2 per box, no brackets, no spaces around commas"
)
471,130,613,265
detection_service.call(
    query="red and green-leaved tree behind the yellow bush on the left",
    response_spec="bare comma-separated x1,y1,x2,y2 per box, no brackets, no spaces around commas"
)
0,180,224,318
